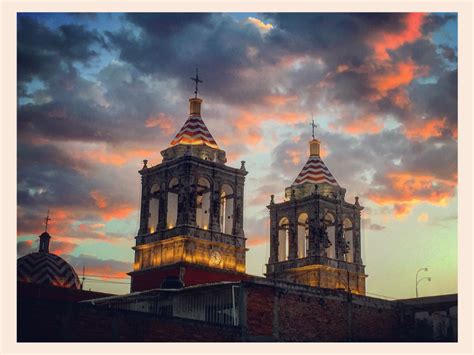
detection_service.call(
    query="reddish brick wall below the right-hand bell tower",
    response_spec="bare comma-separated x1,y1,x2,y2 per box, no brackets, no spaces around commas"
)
246,283,400,342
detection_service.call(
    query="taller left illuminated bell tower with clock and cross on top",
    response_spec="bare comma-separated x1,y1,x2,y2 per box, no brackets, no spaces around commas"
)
130,73,247,292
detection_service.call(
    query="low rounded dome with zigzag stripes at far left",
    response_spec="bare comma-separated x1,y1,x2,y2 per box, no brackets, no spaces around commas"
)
17,252,80,289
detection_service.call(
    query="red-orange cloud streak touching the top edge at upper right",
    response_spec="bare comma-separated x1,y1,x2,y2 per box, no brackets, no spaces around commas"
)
369,13,426,60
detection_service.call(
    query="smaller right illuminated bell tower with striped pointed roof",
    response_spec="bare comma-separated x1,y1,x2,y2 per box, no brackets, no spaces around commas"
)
266,126,366,294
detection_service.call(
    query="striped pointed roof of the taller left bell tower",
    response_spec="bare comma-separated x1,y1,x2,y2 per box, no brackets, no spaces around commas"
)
171,114,219,149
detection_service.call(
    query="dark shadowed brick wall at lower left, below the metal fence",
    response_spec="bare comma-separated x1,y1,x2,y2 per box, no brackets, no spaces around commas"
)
18,298,241,342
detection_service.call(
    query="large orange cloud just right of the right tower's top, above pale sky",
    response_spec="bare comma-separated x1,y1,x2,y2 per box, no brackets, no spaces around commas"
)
368,172,457,218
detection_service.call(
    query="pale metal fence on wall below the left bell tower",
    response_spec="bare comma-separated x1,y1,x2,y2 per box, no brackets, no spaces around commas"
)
88,284,240,326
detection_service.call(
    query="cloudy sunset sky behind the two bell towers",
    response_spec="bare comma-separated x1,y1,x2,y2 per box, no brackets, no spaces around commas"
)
17,13,458,298
